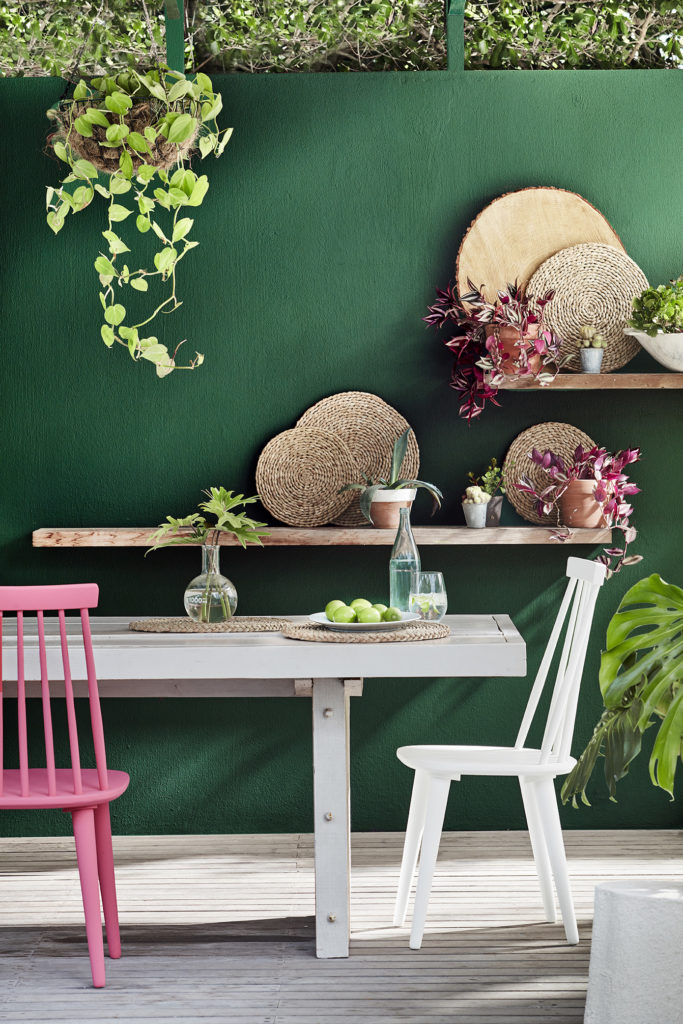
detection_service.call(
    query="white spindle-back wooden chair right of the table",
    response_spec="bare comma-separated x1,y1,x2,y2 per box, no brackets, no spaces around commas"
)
394,558,605,949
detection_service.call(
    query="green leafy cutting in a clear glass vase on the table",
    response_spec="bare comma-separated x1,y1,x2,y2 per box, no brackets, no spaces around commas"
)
146,487,268,624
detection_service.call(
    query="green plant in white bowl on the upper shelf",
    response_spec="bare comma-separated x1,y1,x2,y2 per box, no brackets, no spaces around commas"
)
626,275,683,373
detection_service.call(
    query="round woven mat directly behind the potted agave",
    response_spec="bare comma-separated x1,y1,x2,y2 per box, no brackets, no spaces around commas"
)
297,391,420,526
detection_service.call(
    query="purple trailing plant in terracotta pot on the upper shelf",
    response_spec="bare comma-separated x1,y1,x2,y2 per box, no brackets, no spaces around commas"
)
423,279,560,423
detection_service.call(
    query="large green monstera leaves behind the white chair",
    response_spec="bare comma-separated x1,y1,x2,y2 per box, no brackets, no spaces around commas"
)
562,573,683,806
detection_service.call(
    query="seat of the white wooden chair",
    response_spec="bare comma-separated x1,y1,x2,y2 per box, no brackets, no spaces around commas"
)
396,745,577,780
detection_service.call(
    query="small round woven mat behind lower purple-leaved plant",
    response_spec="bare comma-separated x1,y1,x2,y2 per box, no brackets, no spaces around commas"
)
503,423,595,526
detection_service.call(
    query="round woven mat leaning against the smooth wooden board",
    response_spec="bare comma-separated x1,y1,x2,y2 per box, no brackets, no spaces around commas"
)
526,244,648,374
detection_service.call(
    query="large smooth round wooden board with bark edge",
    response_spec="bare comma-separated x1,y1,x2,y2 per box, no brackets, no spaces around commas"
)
456,187,626,301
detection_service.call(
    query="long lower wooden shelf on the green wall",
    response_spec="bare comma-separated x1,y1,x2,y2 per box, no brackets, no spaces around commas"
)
33,526,611,548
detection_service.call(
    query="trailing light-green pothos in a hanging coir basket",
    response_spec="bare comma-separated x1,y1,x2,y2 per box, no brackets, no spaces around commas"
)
47,69,232,377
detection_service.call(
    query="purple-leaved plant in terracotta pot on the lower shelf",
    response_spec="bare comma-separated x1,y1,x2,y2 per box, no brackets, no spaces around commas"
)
515,444,642,578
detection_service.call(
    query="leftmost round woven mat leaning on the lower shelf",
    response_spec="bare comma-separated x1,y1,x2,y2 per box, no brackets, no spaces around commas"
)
256,426,360,526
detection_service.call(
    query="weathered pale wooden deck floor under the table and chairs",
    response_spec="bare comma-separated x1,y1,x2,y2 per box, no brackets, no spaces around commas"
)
0,831,683,1024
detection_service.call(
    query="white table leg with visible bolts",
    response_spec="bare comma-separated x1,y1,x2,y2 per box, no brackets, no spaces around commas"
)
312,679,351,958
